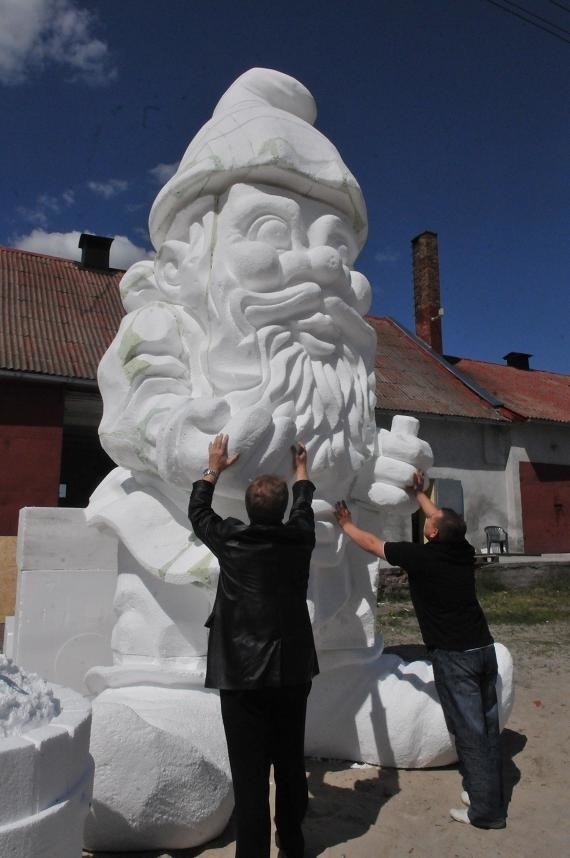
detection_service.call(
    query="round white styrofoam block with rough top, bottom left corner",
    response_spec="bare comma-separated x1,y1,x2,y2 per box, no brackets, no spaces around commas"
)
0,654,93,858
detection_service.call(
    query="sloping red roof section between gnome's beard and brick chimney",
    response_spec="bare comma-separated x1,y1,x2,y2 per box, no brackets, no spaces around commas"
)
367,316,508,423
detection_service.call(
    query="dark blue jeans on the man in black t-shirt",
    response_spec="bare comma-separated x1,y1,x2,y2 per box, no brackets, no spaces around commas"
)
431,644,506,828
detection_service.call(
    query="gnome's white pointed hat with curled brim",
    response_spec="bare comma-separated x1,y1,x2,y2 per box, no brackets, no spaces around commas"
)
149,68,367,248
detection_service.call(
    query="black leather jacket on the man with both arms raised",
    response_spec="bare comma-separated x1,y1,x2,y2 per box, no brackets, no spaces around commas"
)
188,480,319,689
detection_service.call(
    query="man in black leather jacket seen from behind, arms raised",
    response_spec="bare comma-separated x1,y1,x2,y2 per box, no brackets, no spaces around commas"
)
188,435,319,858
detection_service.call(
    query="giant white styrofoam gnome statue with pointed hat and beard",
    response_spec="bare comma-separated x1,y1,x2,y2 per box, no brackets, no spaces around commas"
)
83,69,510,848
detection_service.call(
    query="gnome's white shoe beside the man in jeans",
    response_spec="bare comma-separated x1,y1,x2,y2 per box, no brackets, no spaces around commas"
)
305,644,513,769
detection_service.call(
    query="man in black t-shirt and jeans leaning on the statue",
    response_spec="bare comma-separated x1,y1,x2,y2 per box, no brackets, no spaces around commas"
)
335,471,506,828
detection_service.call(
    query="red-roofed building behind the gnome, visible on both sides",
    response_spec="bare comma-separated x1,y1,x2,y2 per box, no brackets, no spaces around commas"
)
0,232,570,613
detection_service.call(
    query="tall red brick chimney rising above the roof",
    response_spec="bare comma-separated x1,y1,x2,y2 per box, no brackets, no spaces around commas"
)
412,231,443,354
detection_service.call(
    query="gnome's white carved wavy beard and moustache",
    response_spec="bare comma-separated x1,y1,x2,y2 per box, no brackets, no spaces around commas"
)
208,283,374,493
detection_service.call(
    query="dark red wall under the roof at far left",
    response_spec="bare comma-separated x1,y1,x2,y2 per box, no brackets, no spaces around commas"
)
0,382,63,536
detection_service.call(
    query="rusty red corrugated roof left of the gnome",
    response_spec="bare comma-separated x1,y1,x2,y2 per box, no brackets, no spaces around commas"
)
0,247,125,379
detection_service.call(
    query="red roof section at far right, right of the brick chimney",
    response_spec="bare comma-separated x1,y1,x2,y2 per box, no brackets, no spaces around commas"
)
448,358,570,423
